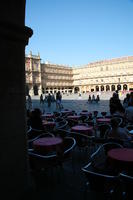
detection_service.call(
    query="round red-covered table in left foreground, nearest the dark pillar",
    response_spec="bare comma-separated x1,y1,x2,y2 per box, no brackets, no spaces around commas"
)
33,137,63,153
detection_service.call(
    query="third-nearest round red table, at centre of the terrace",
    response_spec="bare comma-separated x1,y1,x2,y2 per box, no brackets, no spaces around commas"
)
71,125,93,135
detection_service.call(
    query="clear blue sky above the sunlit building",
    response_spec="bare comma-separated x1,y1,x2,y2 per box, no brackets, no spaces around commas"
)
25,0,133,66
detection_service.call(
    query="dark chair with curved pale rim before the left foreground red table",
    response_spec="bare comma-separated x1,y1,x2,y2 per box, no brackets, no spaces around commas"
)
28,137,76,177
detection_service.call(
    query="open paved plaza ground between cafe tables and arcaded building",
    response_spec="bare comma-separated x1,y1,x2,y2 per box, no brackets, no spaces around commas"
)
29,92,126,113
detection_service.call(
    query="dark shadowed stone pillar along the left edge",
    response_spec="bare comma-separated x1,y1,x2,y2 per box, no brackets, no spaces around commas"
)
0,0,32,199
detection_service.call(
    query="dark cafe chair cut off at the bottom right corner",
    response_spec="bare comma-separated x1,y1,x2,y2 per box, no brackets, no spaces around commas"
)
120,171,133,200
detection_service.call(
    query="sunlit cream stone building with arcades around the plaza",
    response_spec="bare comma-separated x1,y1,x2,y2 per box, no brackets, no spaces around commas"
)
25,53,133,95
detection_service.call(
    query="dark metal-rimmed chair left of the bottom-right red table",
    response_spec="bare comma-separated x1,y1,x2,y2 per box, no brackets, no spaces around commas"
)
82,143,122,199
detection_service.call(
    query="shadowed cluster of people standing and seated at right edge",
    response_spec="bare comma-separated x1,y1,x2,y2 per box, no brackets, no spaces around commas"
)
108,91,133,147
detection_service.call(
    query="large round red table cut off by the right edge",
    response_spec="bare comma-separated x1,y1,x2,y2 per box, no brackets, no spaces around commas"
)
107,148,133,171
